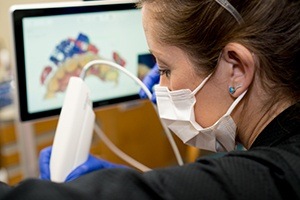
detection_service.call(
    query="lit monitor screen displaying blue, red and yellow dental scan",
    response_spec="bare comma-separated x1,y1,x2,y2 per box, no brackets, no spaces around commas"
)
22,9,152,113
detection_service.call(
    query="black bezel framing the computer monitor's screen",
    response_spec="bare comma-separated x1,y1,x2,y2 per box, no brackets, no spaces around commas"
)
10,0,144,122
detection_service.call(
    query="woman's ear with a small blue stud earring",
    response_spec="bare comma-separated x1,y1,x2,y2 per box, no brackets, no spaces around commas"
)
222,43,256,98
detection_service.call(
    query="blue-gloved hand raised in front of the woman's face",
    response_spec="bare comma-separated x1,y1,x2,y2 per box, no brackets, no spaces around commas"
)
139,64,159,103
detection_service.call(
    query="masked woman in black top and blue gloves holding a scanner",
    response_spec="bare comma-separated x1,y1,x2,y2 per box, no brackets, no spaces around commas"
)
0,0,300,200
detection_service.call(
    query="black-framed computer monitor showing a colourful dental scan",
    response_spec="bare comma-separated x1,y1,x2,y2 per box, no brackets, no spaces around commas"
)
10,0,154,122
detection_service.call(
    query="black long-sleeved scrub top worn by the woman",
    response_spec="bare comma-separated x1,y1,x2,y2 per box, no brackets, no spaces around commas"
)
0,103,300,200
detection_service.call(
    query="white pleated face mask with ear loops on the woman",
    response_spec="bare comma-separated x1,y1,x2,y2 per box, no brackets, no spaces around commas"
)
154,75,246,152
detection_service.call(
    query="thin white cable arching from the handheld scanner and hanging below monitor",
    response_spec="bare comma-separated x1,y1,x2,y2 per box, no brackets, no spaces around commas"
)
80,60,184,167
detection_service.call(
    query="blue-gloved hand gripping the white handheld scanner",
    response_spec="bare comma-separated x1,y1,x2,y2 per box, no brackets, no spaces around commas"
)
39,146,126,182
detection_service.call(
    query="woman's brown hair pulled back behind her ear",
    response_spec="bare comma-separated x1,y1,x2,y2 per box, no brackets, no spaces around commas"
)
138,0,300,102
